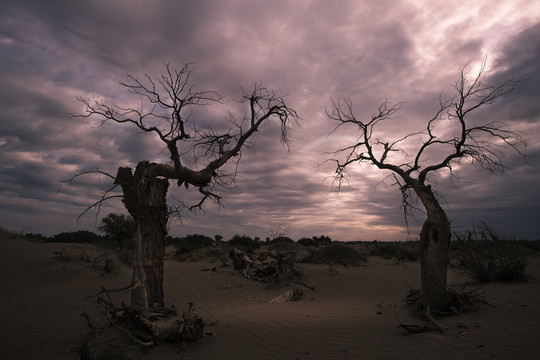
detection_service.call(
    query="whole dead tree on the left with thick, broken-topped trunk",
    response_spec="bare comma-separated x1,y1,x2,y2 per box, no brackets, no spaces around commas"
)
71,63,299,312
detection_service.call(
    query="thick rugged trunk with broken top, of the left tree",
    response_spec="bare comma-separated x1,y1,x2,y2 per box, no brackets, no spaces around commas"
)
116,161,169,312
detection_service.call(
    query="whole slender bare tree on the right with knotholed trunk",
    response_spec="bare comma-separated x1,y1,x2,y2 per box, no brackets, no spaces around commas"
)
327,60,527,311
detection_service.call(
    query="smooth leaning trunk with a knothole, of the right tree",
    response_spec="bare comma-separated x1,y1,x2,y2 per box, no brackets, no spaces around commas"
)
414,185,451,312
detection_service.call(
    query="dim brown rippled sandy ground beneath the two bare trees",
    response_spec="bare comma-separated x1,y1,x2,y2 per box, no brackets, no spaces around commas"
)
0,238,540,360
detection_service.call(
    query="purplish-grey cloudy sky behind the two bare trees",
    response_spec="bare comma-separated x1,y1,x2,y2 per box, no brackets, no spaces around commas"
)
0,0,540,240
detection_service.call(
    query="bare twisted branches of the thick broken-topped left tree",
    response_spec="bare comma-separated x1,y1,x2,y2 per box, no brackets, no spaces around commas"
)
69,62,300,225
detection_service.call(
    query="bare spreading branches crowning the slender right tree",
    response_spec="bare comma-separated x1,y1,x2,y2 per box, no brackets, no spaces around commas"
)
326,60,527,229
